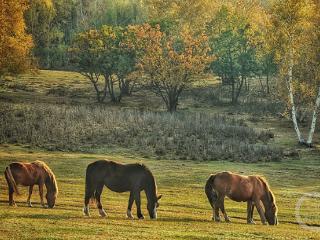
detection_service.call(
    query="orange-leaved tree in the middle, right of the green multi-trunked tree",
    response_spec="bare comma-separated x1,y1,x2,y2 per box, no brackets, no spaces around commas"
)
129,24,211,112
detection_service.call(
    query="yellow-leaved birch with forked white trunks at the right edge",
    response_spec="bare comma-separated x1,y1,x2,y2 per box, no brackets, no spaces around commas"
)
270,0,320,146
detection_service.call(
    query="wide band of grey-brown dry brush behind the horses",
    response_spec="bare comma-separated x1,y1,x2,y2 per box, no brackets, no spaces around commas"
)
0,104,282,162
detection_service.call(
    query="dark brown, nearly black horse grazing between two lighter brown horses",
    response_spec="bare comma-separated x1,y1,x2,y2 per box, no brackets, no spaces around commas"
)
83,160,161,219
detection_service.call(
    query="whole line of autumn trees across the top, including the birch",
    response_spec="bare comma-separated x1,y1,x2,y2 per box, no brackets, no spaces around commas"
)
0,0,320,145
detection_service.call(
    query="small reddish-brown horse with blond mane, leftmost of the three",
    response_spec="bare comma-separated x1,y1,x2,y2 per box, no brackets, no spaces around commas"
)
4,161,58,208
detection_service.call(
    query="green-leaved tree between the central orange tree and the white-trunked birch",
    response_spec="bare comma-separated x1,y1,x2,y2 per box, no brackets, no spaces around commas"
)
207,6,257,104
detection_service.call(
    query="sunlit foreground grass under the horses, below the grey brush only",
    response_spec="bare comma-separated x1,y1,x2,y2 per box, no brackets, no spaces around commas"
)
0,145,320,239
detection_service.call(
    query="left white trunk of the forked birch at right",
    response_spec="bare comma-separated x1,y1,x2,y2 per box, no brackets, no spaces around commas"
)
287,48,304,143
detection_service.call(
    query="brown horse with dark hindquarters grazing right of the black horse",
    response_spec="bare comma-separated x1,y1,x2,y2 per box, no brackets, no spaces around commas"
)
205,172,278,225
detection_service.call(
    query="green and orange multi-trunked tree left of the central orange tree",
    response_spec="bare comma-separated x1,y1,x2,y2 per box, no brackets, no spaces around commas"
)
71,25,136,102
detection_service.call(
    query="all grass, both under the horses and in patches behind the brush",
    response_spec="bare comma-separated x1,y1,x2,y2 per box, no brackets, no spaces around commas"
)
0,71,320,239
